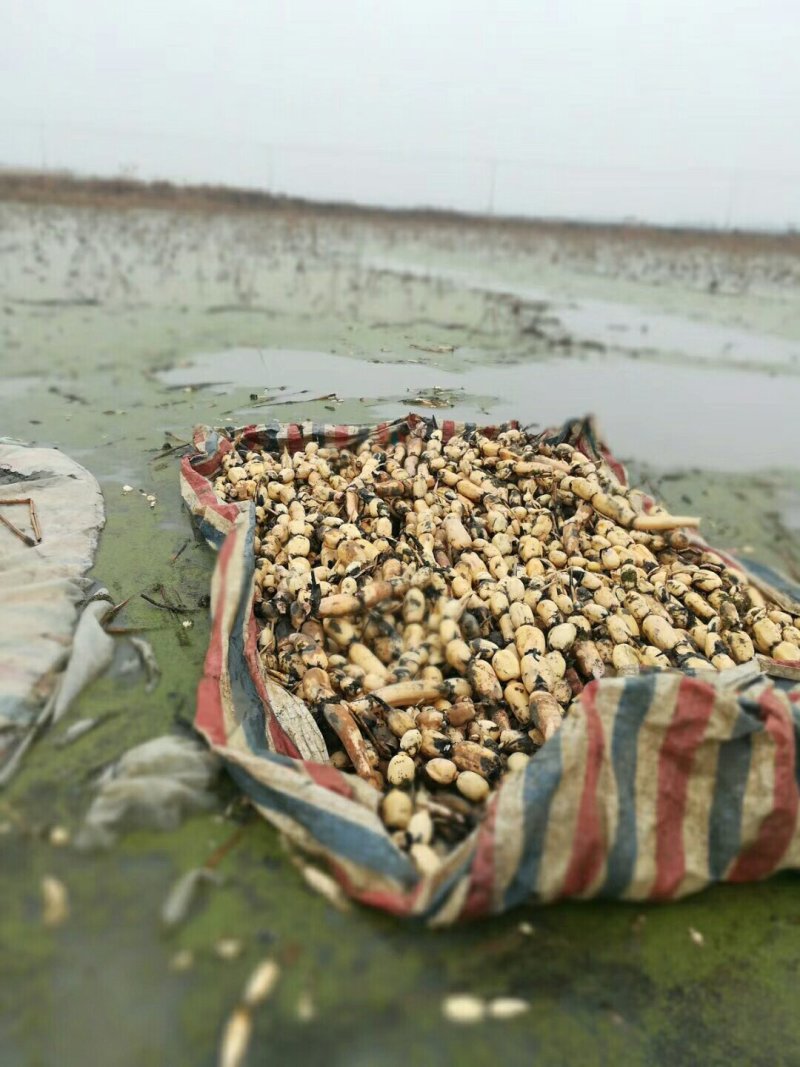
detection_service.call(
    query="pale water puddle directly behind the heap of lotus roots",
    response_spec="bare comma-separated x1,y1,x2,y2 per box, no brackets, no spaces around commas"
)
158,348,800,471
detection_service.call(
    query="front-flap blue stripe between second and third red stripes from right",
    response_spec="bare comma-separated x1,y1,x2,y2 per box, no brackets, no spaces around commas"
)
598,673,657,896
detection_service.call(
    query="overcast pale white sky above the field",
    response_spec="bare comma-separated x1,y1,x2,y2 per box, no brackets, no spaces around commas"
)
0,0,800,226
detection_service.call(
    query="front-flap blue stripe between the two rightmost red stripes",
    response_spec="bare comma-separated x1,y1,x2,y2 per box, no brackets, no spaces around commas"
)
708,697,764,881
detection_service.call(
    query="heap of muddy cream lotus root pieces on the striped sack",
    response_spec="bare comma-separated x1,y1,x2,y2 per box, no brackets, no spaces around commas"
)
214,429,800,872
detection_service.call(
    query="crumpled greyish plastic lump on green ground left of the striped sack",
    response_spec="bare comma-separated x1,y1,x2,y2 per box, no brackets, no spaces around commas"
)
75,735,219,849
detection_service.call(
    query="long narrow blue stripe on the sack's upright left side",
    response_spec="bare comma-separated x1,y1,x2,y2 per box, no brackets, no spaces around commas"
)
227,507,270,755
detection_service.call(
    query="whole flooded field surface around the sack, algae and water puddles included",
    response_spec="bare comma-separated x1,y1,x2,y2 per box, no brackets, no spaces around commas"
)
0,196,800,1067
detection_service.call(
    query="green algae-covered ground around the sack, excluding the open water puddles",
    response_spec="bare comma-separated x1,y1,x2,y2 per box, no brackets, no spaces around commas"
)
0,198,800,1067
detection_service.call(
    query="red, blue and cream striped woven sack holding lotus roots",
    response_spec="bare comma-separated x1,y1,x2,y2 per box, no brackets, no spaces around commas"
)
181,415,800,924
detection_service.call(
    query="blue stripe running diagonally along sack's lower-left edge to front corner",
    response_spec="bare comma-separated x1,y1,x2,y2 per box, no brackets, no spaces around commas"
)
227,753,419,889
